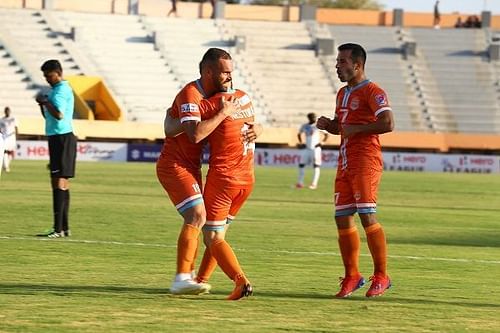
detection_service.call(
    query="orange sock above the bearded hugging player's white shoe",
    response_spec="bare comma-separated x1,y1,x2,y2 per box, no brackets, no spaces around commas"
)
177,224,200,274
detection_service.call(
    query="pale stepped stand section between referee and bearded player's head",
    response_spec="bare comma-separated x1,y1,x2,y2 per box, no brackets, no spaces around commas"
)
52,11,181,123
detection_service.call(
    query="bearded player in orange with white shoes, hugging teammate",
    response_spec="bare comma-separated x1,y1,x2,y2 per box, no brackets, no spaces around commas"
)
156,48,241,294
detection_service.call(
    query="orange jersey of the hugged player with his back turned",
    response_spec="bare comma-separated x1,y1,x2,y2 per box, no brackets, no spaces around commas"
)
200,90,255,188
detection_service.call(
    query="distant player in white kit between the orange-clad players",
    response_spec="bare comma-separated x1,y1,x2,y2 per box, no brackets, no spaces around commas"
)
295,113,328,190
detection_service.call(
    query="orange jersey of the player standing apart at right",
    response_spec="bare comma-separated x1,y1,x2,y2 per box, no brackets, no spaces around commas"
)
335,80,391,170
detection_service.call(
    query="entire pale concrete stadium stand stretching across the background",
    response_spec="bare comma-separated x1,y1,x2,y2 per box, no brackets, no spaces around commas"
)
0,3,500,144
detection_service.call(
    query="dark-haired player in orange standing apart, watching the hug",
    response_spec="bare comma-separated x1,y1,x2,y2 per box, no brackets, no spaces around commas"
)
317,43,394,298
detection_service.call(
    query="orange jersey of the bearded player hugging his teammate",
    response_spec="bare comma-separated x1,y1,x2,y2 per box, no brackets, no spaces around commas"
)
158,80,206,169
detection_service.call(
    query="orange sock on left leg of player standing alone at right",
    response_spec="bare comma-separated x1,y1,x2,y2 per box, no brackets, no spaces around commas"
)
338,226,361,276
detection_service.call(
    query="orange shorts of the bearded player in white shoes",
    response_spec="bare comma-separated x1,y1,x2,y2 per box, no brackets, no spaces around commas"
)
156,163,203,214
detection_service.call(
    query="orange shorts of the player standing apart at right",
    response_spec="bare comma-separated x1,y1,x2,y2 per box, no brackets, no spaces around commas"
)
335,168,382,216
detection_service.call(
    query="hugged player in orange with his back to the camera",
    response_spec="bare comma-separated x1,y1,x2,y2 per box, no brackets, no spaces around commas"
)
193,90,262,300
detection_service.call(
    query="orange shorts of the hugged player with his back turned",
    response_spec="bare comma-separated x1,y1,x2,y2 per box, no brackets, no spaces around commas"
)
203,178,253,231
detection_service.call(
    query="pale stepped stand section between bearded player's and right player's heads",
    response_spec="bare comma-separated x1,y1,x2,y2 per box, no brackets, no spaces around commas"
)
217,20,335,127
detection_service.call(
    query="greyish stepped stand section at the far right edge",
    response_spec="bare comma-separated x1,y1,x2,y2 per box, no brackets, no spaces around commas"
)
409,28,500,133
